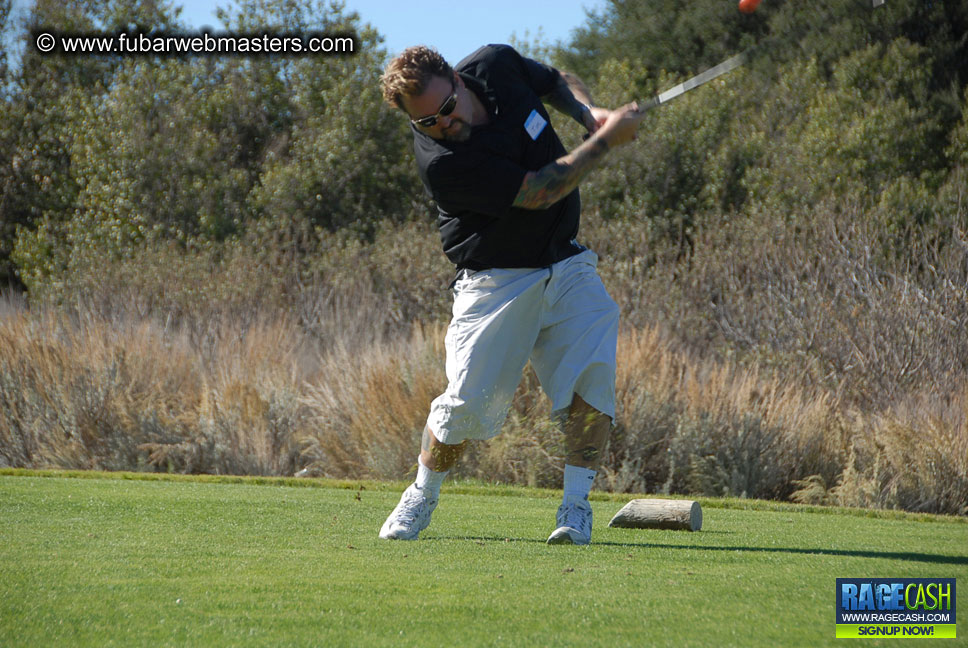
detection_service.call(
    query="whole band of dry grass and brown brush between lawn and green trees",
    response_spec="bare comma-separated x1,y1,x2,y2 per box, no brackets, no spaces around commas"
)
0,195,968,513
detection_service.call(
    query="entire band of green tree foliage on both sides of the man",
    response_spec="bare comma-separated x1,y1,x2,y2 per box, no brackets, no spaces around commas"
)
0,0,968,308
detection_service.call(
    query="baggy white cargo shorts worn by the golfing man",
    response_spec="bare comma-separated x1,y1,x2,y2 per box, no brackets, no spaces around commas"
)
427,250,619,444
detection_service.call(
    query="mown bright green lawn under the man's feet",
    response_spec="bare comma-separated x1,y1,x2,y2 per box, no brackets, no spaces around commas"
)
0,471,968,647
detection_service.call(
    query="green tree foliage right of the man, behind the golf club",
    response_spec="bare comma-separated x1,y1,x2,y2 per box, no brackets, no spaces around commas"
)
557,0,968,254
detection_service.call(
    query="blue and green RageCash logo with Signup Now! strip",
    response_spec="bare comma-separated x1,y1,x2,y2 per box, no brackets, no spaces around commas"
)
836,578,957,639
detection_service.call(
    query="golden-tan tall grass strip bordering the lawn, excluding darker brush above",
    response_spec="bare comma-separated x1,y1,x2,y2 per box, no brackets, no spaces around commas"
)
0,292,968,513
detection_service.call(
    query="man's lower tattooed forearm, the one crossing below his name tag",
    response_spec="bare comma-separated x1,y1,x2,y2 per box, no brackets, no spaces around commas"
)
514,137,608,209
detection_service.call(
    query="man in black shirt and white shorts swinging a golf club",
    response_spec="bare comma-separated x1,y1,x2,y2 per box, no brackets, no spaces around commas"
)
380,45,643,544
